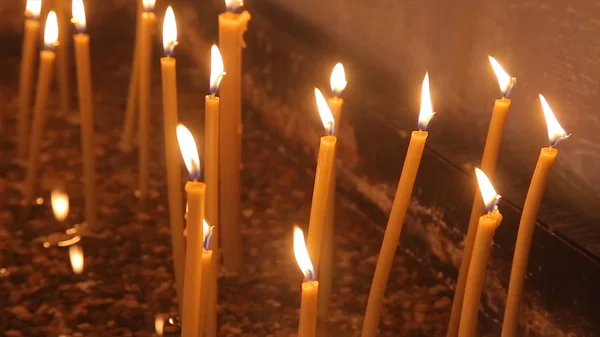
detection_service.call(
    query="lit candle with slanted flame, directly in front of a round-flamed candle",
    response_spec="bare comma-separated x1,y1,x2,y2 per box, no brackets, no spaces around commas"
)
307,88,337,271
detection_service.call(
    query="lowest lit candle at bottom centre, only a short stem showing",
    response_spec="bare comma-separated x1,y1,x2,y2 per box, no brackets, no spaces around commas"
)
294,226,319,337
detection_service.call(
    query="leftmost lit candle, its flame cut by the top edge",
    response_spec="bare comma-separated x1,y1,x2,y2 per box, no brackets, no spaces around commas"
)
17,0,42,160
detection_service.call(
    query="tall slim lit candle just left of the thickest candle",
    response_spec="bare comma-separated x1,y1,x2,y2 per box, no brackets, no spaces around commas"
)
204,46,226,337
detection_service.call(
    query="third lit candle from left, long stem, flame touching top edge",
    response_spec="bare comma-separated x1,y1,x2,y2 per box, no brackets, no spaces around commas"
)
72,0,96,228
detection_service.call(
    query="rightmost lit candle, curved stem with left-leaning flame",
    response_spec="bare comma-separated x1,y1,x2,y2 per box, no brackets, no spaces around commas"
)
502,95,570,337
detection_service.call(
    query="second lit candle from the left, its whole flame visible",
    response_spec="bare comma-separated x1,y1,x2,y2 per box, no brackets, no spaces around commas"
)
23,11,58,205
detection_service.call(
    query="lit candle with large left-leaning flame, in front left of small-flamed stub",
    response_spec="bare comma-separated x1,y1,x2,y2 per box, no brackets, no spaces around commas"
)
177,124,206,337
